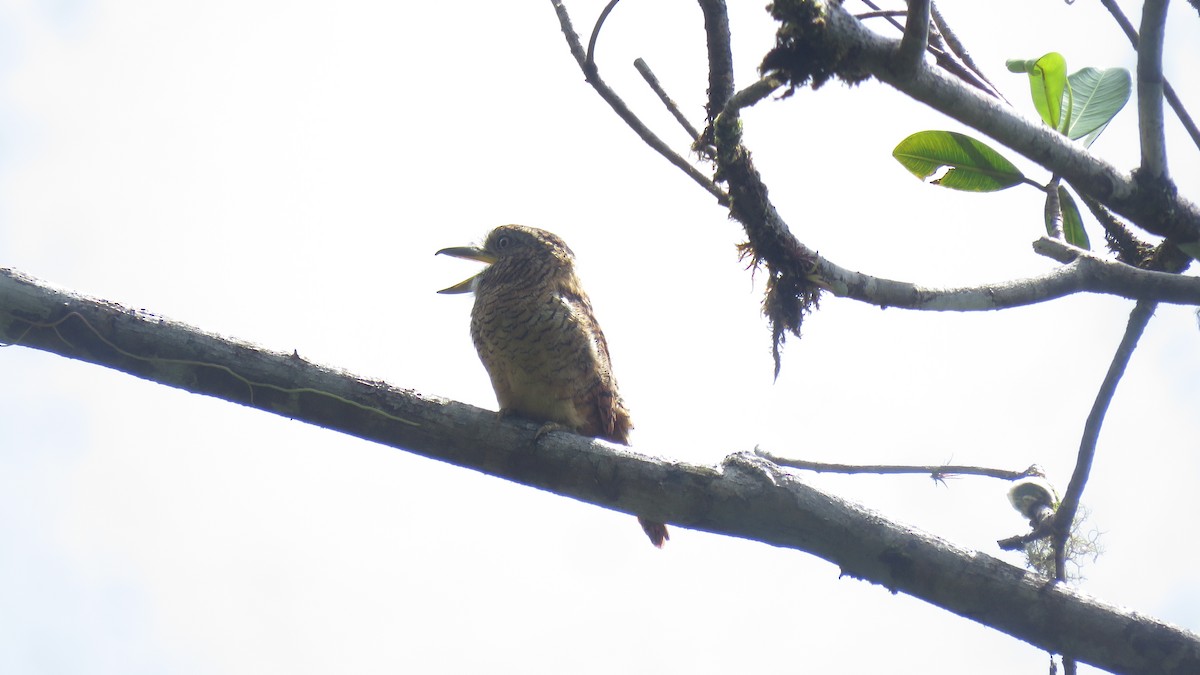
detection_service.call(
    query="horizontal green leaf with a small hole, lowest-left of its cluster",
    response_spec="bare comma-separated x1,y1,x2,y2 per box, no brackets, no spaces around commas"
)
892,131,1025,192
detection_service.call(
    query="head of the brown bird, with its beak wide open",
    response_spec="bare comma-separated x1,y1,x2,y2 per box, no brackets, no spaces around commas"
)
438,225,575,293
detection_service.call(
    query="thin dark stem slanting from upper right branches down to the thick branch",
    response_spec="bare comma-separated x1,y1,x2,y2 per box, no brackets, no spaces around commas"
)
1054,301,1158,581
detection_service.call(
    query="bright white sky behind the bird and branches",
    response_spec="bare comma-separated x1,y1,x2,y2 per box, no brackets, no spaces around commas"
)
0,0,1200,674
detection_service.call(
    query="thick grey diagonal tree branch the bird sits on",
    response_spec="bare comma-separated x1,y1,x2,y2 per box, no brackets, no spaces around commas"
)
0,264,1200,674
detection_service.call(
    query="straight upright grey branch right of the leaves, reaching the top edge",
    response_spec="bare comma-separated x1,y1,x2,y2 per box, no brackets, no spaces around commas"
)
1138,0,1168,179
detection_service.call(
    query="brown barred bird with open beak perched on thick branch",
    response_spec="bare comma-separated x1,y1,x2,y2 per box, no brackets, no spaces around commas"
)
438,225,668,548
